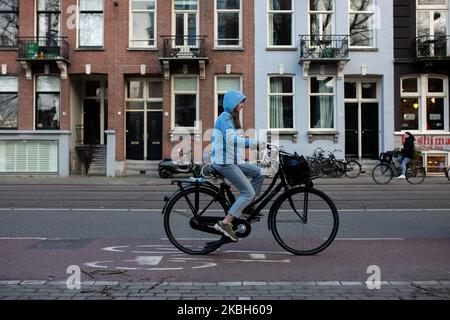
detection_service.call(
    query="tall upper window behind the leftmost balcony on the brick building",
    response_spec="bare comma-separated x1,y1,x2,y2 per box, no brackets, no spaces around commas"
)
37,0,61,39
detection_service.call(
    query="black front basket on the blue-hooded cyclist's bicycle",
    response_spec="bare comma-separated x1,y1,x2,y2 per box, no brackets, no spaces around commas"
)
280,153,311,186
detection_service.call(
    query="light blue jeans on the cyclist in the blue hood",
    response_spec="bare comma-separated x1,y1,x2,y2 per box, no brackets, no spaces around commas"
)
213,163,264,217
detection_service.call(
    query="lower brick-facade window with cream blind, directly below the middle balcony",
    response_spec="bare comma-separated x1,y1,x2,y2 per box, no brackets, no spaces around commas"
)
172,76,199,129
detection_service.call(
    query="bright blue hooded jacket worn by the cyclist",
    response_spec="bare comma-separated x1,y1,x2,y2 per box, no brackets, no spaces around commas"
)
212,90,256,165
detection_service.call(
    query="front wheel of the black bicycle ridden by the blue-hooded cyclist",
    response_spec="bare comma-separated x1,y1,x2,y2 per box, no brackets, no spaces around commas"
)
269,187,339,255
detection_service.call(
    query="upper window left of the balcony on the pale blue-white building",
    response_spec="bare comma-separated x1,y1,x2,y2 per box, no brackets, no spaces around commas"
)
268,0,294,46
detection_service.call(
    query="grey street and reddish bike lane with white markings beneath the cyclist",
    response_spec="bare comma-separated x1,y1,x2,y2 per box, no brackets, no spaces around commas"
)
0,178,450,300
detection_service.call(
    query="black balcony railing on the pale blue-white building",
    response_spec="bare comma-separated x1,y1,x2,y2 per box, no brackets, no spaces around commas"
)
300,35,348,60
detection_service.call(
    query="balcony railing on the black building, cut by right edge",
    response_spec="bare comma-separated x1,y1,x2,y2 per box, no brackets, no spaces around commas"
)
416,36,450,58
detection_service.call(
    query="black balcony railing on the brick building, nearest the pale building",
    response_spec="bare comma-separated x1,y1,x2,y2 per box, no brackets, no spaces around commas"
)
162,36,206,60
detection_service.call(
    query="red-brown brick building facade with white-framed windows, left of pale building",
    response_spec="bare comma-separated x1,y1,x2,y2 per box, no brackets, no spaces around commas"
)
0,0,255,176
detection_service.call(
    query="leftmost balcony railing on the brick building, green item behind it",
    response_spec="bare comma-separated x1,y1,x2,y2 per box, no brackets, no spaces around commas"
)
19,37,69,61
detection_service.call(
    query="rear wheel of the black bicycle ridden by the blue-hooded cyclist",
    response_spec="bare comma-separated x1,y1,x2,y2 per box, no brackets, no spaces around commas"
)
164,186,227,255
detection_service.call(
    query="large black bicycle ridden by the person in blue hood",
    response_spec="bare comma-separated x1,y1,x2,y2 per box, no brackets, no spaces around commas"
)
162,145,339,255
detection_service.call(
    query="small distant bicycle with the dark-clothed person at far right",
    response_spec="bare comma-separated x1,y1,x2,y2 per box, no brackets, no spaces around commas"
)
372,151,426,184
